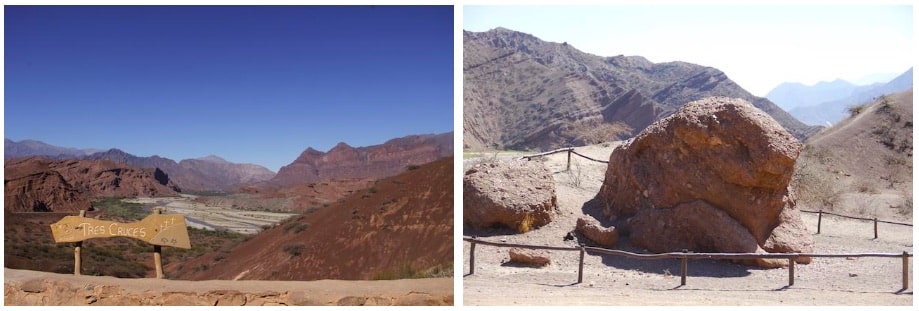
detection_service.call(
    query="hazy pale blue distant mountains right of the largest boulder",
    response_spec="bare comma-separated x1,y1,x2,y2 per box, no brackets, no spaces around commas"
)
766,68,913,125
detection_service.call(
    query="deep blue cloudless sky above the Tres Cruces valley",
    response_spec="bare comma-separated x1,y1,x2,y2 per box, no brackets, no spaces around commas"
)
3,6,454,171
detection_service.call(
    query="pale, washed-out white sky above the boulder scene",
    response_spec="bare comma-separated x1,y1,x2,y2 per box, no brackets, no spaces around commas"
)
463,4,916,96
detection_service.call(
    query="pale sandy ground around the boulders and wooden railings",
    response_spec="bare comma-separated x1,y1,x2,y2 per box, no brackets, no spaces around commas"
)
463,144,913,305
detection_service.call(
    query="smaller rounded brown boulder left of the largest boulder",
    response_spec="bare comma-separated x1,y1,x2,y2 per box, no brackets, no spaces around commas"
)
463,160,558,232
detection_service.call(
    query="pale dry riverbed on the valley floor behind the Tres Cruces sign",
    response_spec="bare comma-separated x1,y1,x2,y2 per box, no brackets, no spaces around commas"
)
124,194,296,234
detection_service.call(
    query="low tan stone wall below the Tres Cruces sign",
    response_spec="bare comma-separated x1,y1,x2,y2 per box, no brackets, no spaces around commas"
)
3,269,453,306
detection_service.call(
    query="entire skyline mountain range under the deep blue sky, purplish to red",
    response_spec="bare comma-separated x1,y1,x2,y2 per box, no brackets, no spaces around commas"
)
4,132,453,192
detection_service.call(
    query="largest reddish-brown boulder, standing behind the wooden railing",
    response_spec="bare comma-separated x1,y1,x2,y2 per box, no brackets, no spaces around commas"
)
598,97,813,267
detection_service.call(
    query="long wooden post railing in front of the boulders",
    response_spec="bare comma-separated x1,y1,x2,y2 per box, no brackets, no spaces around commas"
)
463,237,913,290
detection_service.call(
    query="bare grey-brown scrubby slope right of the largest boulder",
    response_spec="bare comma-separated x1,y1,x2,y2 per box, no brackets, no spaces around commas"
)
793,90,913,219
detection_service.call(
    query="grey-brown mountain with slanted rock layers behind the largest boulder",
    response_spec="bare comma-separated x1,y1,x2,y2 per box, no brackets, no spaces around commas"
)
463,28,818,149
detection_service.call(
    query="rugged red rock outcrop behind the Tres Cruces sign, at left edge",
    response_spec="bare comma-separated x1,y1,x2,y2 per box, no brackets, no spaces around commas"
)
3,157,178,212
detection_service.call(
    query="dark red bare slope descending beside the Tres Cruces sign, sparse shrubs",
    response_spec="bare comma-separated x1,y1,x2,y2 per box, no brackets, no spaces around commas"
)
166,157,453,280
